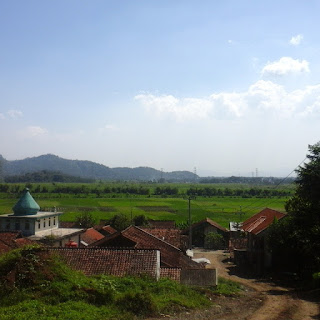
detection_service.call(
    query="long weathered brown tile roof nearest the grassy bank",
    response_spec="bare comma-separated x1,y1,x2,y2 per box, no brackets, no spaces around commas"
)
47,248,160,278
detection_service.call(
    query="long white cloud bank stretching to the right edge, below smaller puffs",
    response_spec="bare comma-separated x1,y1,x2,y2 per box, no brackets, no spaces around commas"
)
135,80,320,121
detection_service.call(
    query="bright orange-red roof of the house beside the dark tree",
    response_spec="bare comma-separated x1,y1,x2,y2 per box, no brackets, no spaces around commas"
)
242,208,286,235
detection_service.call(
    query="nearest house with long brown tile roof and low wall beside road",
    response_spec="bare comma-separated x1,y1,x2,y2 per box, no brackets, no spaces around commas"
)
42,247,217,286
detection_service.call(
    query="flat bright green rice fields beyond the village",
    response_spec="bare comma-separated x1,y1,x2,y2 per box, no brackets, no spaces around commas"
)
0,185,289,227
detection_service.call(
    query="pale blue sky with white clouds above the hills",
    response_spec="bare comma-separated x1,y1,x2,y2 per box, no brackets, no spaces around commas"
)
0,0,320,176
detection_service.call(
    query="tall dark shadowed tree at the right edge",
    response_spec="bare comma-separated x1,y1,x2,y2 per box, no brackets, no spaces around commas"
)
269,142,320,276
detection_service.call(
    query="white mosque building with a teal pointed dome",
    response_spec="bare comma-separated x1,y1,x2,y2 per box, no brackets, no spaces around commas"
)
0,188,83,246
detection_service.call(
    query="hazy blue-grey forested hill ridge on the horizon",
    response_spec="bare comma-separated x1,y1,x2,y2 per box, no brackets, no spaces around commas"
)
0,154,198,182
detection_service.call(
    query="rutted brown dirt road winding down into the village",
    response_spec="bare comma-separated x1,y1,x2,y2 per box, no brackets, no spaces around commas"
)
192,249,320,320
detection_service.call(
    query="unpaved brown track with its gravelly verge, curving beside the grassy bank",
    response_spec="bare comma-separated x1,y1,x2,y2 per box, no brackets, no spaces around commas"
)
149,249,320,320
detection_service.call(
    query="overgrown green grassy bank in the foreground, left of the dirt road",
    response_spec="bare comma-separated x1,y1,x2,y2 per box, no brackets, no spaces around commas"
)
0,247,241,320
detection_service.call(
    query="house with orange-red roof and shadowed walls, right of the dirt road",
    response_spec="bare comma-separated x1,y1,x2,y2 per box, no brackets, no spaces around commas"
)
234,208,286,274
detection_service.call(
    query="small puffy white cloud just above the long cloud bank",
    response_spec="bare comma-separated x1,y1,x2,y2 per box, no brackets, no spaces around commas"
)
261,57,310,76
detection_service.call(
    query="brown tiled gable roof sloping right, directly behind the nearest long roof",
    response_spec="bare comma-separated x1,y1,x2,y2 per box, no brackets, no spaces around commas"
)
95,226,199,269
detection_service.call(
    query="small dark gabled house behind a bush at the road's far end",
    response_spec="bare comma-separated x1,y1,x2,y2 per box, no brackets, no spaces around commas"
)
183,218,229,247
